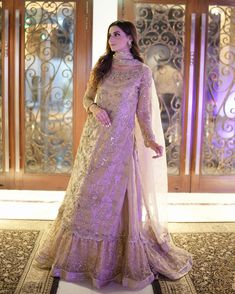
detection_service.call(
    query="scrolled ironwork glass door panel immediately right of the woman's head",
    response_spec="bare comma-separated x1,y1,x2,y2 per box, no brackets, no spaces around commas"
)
135,3,185,175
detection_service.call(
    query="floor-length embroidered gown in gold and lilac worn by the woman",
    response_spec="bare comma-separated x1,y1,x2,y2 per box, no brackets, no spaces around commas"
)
36,54,192,289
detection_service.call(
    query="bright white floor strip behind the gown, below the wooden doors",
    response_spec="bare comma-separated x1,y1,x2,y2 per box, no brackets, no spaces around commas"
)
0,190,235,222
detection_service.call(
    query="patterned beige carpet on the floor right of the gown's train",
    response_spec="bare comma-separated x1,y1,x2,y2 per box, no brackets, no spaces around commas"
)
171,232,235,294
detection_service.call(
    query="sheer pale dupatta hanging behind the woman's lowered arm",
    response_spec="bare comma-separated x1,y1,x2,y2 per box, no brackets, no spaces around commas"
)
135,80,170,251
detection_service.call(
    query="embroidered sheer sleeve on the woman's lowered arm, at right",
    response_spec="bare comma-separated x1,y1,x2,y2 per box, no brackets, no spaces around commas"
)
136,67,155,147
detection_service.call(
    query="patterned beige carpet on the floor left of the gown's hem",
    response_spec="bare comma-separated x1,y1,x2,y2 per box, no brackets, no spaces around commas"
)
0,229,53,294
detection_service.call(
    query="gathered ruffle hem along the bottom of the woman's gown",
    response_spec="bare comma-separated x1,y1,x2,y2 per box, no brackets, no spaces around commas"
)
36,224,192,289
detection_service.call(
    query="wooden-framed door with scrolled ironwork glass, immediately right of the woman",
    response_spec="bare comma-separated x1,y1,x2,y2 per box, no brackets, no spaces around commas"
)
119,0,195,191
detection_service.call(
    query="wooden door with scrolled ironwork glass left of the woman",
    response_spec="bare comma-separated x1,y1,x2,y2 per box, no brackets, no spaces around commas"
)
0,0,92,190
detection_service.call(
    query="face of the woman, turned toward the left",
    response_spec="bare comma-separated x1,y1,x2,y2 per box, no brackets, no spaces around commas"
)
108,26,132,52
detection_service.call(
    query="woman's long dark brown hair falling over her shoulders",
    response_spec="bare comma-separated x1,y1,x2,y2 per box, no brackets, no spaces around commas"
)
91,20,143,88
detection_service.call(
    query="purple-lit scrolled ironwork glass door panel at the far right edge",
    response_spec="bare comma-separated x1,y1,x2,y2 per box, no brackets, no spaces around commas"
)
201,5,235,176
